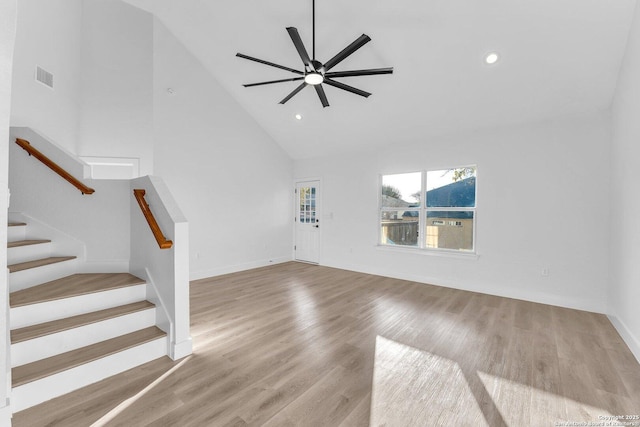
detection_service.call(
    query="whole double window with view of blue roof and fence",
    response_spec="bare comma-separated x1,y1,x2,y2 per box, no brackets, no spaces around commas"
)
380,166,476,252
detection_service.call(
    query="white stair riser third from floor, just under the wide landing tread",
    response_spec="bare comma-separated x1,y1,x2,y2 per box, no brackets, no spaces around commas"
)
9,284,147,329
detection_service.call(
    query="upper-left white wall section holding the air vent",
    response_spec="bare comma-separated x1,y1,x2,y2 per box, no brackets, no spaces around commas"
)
11,0,82,153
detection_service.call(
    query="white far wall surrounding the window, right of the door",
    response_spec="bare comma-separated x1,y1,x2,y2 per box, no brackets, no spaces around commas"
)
294,115,609,312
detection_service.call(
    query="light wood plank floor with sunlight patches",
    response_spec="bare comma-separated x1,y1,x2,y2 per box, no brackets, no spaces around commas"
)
13,263,640,427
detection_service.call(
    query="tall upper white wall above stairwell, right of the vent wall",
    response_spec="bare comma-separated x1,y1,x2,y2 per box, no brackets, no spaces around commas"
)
77,0,153,175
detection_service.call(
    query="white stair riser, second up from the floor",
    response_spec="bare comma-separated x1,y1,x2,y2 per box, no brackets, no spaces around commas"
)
11,308,156,367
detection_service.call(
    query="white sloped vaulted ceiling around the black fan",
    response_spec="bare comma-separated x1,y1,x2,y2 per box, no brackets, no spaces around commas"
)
128,0,636,158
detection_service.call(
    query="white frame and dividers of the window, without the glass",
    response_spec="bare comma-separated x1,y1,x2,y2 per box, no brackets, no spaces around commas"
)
377,164,478,256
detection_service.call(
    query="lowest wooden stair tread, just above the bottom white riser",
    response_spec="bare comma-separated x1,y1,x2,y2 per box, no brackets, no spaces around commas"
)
11,326,166,387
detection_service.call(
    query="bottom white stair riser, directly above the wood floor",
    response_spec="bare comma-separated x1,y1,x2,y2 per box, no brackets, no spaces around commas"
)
11,337,167,412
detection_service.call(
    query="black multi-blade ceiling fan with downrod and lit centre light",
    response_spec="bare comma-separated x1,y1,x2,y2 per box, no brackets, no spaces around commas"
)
236,0,393,107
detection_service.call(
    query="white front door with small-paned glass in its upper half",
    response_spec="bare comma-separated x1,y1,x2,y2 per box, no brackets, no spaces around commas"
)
295,181,320,264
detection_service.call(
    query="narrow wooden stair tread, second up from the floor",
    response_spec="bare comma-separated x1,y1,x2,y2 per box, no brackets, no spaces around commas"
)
11,301,155,344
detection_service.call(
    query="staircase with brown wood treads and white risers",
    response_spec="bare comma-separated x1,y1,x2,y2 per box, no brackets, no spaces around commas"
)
7,222,168,412
